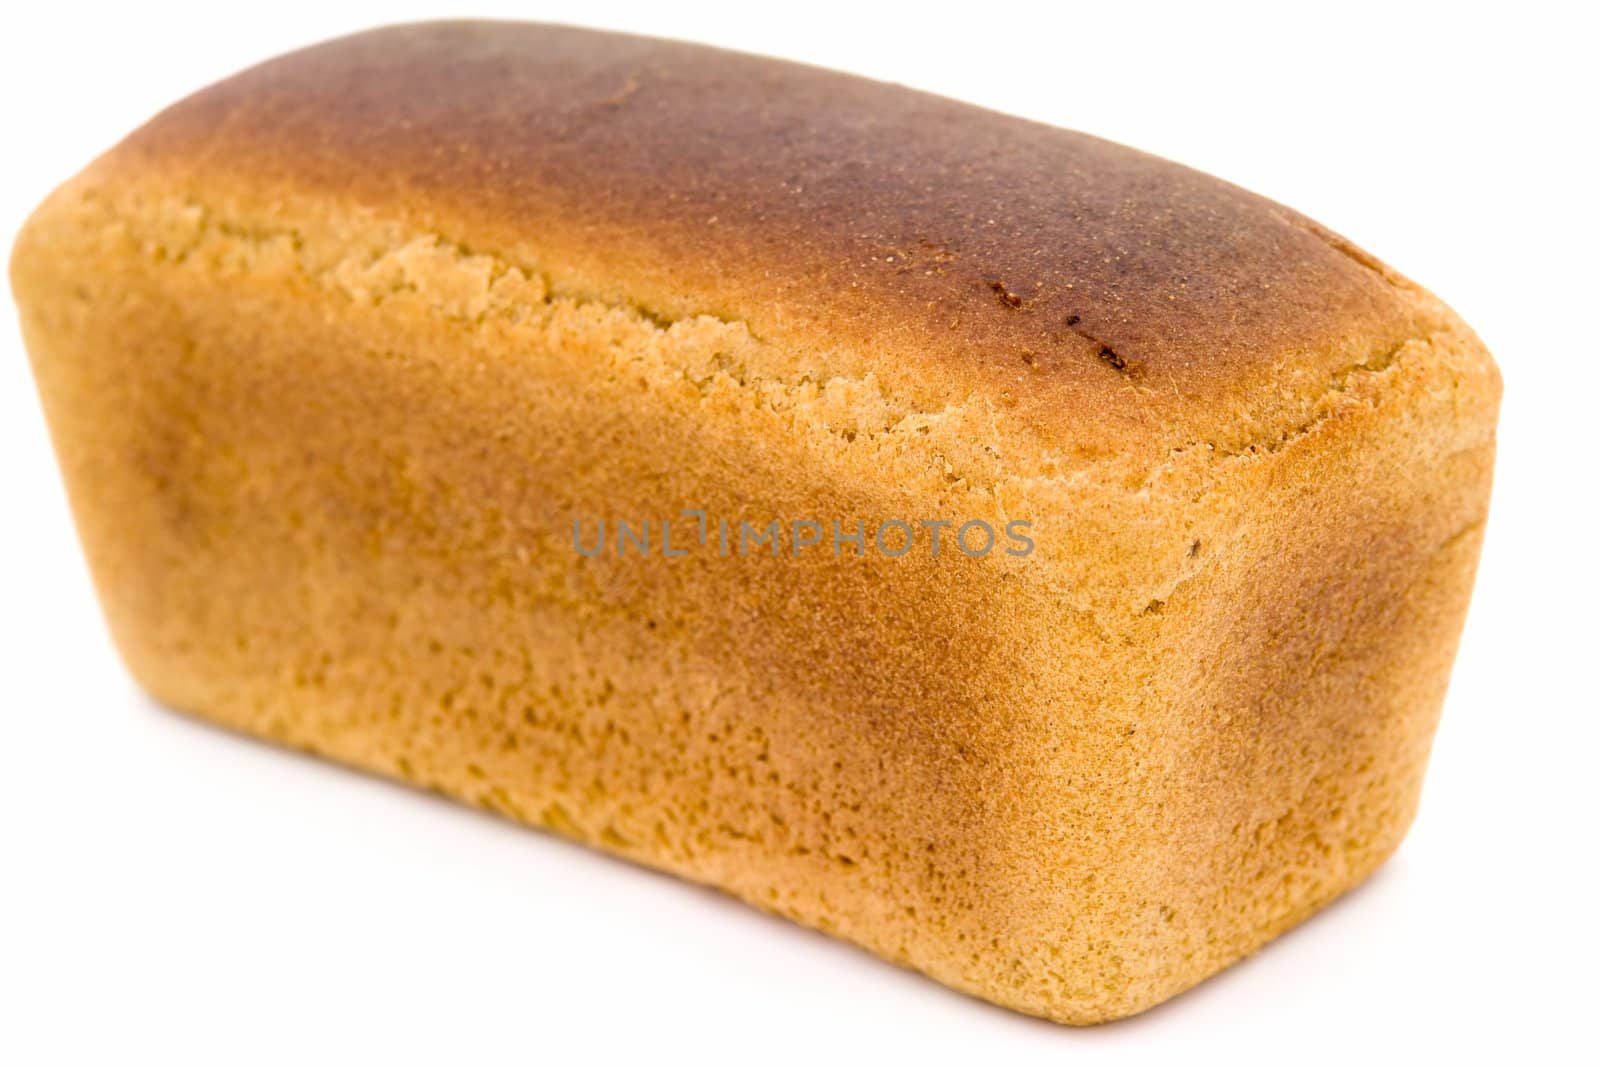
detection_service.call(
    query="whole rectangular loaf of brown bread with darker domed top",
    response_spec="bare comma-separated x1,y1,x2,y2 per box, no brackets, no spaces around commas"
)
11,22,1499,1024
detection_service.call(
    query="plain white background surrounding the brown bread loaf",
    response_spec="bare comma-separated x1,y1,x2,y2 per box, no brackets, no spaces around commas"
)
0,0,1600,1064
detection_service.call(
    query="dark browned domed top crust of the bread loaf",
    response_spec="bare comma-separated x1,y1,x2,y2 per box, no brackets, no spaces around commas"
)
114,22,1432,447
